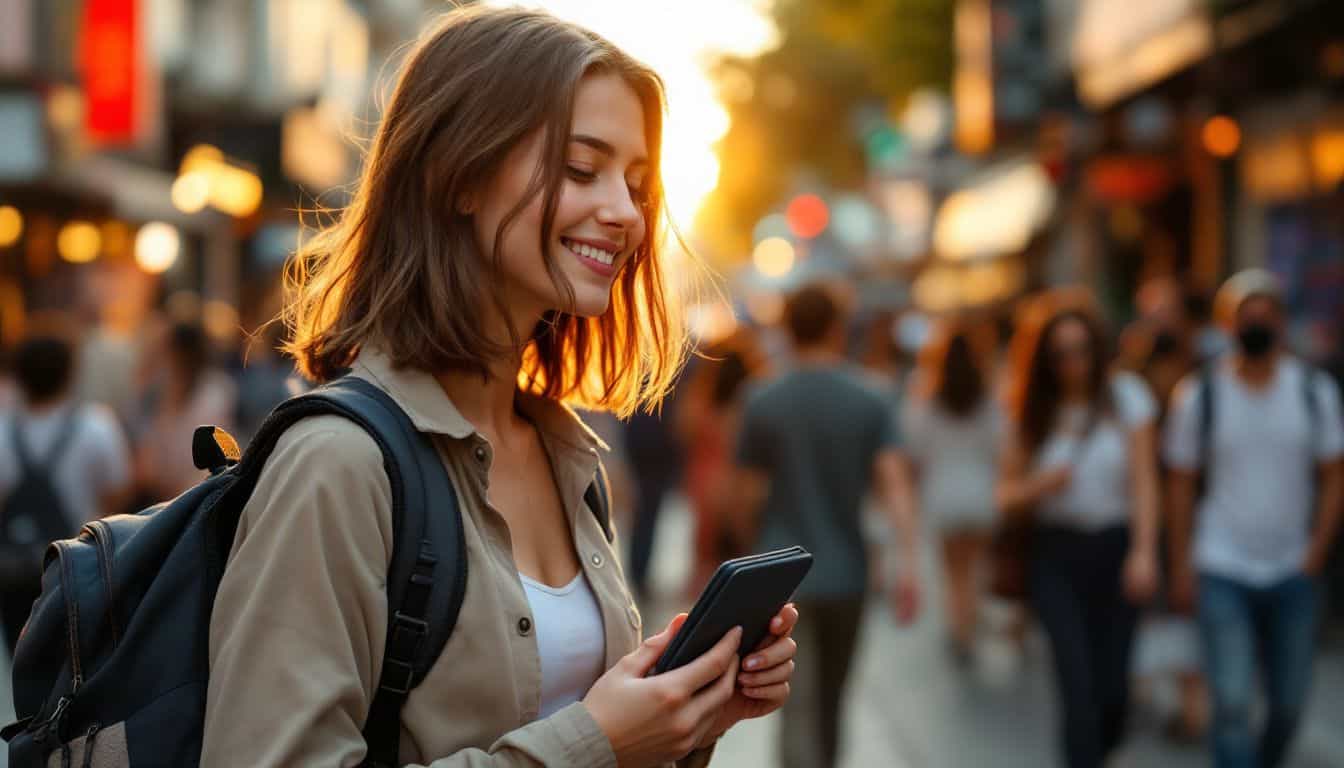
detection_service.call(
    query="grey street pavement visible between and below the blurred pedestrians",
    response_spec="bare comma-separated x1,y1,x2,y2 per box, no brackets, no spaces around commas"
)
646,500,1344,768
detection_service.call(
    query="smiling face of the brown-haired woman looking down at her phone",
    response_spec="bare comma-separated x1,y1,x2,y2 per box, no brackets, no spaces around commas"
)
472,74,650,324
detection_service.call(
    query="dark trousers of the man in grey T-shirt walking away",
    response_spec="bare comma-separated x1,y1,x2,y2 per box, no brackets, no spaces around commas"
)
780,597,863,768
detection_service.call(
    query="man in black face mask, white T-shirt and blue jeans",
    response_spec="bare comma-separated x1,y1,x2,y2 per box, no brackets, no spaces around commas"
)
1165,270,1344,768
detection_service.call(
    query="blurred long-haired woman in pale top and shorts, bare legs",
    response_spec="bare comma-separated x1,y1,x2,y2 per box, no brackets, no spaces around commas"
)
903,324,1003,660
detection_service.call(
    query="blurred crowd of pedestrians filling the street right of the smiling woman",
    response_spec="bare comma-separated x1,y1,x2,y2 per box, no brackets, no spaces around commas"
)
613,272,1344,768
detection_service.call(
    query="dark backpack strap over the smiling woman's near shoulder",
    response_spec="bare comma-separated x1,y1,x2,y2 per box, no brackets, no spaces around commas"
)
239,377,466,767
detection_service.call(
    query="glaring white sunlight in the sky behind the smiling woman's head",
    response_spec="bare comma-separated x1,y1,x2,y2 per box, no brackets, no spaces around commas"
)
492,0,775,230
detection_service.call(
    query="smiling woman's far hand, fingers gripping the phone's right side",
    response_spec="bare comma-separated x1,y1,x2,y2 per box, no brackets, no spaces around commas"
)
696,603,798,748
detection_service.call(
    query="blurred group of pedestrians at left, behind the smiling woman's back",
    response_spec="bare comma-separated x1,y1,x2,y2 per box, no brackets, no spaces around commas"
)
0,303,298,654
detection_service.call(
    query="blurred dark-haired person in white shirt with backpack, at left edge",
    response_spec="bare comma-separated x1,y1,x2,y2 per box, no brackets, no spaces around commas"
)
0,324,130,654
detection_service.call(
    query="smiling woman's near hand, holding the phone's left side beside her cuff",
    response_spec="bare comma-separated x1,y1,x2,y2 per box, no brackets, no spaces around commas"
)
583,613,742,768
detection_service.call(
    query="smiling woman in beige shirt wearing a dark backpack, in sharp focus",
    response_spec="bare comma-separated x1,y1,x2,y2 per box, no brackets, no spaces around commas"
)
5,7,797,768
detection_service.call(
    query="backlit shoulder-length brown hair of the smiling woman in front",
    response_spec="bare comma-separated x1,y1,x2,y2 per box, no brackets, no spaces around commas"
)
282,7,687,414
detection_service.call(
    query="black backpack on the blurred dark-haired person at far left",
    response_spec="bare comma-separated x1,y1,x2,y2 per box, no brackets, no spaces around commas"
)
0,408,77,593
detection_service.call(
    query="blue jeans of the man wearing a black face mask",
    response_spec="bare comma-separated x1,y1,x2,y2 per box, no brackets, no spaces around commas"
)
1199,573,1318,768
